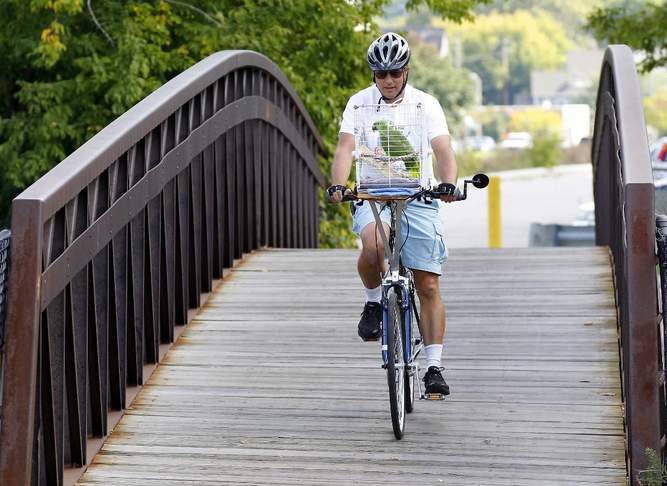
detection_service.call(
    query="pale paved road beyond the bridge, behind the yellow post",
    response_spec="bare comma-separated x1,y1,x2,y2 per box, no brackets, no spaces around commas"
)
442,164,593,248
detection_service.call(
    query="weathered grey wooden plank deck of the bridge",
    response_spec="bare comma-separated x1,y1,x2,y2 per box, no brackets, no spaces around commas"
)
79,248,626,486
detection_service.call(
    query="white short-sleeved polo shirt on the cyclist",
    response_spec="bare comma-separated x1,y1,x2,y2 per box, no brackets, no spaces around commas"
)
339,84,449,181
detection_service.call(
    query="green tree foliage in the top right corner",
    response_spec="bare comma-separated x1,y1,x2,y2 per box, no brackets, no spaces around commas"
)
587,0,667,72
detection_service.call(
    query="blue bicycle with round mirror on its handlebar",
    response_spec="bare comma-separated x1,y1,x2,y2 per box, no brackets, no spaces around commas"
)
336,174,489,440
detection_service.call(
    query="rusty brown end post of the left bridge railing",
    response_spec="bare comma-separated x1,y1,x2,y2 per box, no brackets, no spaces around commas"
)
0,199,42,486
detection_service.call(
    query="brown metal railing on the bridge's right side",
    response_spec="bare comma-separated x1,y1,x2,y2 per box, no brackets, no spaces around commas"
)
592,45,662,484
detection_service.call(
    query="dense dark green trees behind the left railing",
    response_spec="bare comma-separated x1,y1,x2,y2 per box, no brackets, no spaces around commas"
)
0,0,485,246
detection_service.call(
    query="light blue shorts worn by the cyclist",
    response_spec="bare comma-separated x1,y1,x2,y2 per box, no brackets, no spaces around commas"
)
352,200,447,275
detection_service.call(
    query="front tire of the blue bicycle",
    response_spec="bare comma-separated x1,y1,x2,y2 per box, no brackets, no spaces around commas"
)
387,288,406,440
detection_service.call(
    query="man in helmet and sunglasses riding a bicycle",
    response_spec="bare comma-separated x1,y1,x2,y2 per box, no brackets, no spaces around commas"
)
327,32,457,395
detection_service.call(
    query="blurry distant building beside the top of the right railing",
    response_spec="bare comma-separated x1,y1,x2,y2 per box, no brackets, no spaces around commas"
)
530,49,604,105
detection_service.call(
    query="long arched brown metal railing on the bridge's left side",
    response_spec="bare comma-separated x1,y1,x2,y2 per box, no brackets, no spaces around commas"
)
0,51,323,486
